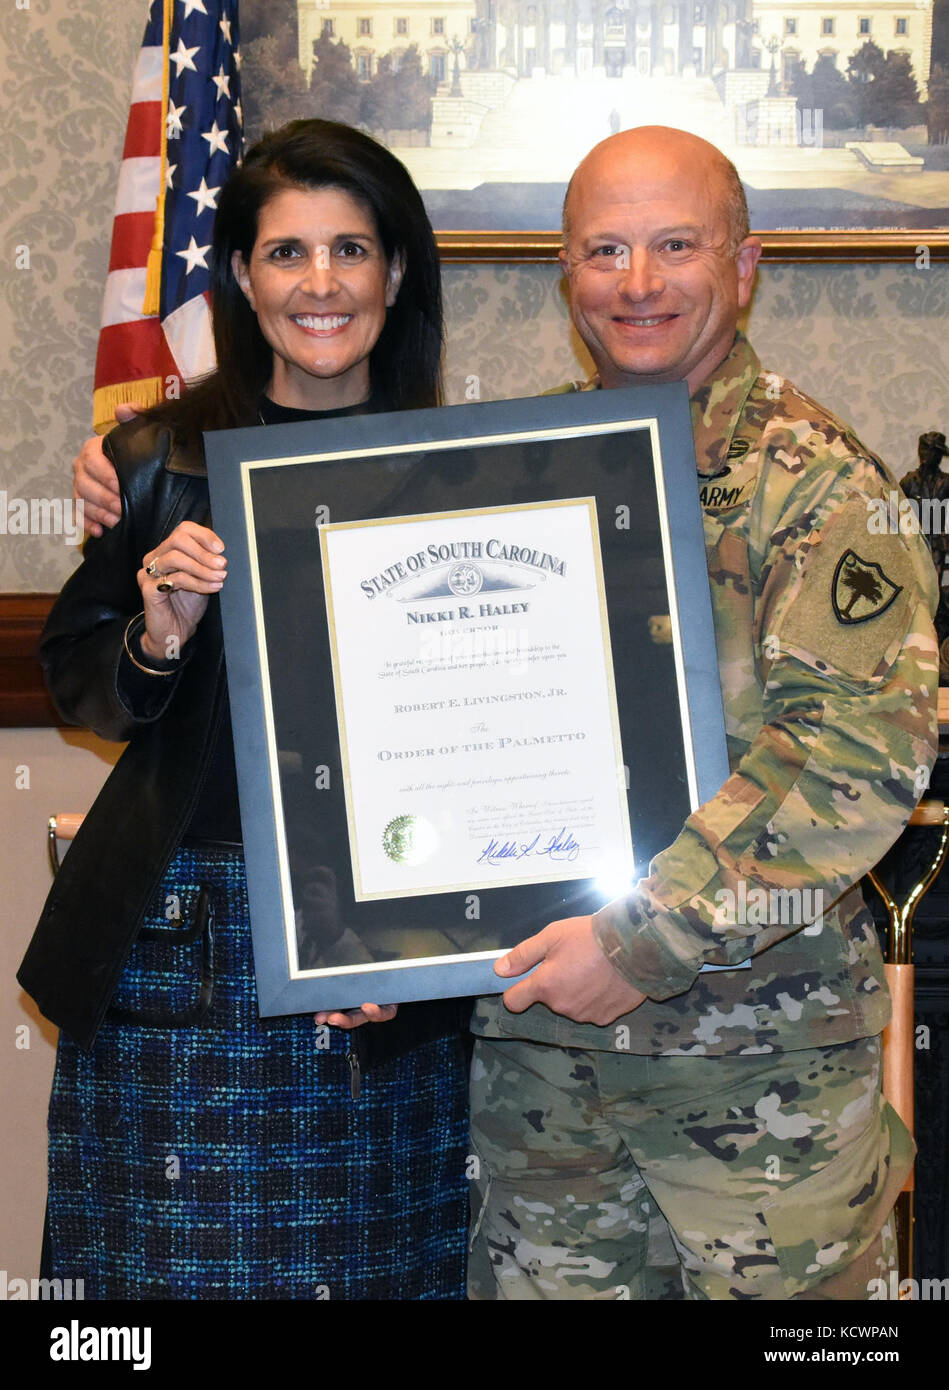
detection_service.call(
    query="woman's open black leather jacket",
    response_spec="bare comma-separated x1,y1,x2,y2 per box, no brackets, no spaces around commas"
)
17,420,464,1065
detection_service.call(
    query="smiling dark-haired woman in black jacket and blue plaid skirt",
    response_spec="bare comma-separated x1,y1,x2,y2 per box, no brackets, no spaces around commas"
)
19,121,467,1298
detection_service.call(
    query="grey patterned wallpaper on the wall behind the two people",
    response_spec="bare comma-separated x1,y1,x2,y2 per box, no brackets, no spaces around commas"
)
0,0,949,592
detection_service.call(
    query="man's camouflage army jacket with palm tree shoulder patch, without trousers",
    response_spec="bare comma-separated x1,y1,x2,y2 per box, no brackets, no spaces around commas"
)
472,334,938,1055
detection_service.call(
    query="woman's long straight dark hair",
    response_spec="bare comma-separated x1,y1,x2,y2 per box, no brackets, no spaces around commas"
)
157,120,443,435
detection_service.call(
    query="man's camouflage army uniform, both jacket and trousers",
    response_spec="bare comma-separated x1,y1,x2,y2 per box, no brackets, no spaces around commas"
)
470,334,938,1298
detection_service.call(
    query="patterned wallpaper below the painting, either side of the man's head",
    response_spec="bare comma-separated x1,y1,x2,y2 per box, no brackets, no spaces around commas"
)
445,263,949,475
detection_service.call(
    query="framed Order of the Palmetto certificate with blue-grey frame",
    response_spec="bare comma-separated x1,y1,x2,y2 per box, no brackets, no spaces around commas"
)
206,384,728,1015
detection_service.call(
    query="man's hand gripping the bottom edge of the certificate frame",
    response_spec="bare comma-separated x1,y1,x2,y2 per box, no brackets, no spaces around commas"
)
495,917,646,1024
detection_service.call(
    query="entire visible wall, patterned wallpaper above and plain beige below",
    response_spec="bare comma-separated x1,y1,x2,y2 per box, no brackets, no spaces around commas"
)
0,0,949,1276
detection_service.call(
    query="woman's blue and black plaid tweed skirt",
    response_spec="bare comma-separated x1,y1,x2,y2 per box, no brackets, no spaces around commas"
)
49,847,468,1300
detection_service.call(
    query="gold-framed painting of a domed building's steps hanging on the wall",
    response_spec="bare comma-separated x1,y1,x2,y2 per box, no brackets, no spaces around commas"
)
242,0,949,260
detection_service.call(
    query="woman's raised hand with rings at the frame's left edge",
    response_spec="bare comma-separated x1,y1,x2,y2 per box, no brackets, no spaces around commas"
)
138,521,228,660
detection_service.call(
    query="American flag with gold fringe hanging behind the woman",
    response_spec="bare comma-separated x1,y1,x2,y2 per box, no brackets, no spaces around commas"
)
93,0,242,431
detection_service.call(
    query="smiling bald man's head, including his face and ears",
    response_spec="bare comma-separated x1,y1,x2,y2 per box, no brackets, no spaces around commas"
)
560,125,761,392
